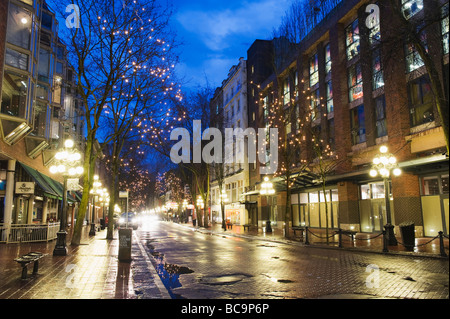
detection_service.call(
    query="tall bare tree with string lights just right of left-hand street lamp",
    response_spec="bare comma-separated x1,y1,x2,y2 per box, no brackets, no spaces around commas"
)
52,0,178,245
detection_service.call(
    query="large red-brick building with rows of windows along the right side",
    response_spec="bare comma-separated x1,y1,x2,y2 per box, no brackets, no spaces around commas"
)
236,0,449,236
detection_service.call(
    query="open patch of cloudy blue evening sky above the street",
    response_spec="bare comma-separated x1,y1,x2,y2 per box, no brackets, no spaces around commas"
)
168,0,291,89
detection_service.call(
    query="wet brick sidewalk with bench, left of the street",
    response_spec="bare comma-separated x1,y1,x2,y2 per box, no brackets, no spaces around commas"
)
0,228,170,299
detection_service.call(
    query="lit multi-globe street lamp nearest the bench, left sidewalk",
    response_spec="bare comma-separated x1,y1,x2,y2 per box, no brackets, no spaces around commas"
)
50,139,84,256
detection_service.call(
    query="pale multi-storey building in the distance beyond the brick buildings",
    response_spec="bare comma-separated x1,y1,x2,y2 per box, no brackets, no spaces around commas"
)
211,58,249,225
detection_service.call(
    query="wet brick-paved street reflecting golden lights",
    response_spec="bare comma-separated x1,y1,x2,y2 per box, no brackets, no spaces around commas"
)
139,220,449,299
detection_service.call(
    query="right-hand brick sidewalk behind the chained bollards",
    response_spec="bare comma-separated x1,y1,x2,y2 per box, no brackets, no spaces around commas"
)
185,224,449,257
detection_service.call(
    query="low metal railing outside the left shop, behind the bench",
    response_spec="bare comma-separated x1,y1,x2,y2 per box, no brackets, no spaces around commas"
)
0,223,59,243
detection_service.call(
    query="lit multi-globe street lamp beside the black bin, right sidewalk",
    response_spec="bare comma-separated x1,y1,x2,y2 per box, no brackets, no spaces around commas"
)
369,146,402,246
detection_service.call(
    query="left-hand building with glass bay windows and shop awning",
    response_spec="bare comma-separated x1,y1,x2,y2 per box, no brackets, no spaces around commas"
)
0,0,84,241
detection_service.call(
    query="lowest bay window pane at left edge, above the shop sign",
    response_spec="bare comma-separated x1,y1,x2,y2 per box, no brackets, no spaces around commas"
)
0,71,28,118
